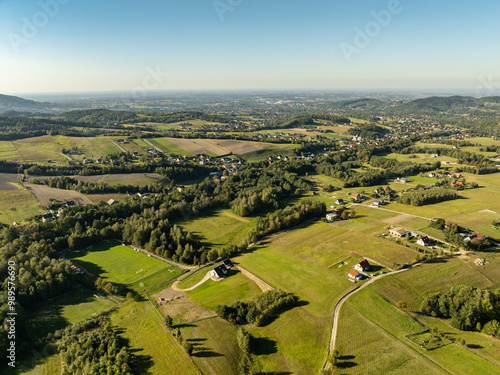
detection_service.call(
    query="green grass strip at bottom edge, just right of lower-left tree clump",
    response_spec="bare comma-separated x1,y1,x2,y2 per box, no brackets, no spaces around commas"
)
110,301,200,375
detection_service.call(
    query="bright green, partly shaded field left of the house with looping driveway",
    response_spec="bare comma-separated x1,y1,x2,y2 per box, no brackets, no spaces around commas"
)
68,241,181,291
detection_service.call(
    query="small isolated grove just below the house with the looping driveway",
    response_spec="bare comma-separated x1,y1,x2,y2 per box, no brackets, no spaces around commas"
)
216,289,298,327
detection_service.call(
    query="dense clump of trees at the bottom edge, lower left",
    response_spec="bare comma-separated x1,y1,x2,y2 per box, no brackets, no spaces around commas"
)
53,316,132,375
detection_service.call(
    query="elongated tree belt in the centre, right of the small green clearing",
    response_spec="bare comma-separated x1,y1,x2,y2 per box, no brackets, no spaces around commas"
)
249,199,326,242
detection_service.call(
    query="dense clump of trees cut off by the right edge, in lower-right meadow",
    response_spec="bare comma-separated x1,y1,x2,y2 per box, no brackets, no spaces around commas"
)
421,286,500,338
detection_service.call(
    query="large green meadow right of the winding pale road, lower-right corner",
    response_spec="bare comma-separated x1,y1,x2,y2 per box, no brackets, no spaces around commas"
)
336,259,500,374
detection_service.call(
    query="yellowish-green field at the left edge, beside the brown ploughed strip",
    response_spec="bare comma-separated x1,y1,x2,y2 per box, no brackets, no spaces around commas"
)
0,183,44,225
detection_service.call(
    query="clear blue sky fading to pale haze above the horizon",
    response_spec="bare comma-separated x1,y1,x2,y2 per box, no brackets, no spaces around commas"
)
0,0,500,94
